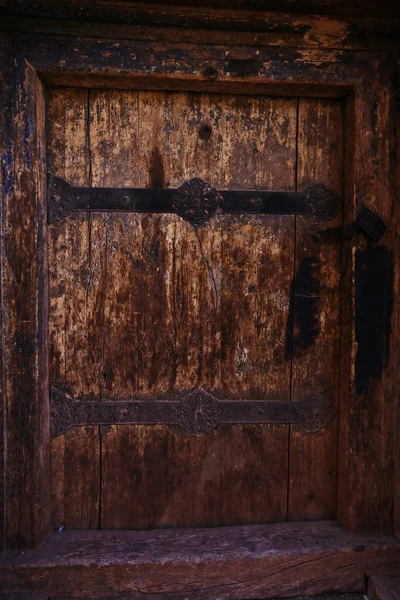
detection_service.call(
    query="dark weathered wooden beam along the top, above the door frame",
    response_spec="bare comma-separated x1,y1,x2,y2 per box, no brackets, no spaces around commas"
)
0,13,400,50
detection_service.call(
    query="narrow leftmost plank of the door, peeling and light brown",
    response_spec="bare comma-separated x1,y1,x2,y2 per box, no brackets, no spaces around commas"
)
47,88,100,528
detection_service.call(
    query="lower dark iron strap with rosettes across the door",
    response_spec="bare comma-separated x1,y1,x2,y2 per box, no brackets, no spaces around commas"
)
50,388,335,437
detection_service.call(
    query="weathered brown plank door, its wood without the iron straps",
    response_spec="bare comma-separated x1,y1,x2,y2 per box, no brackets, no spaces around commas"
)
47,88,343,528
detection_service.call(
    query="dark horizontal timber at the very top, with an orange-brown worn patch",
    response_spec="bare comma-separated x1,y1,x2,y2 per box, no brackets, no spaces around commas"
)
0,0,400,49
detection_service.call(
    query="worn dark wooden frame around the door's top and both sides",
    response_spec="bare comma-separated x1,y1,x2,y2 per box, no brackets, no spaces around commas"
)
0,11,400,592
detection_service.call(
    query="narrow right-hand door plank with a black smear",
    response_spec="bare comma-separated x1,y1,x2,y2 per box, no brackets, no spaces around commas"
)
288,99,344,520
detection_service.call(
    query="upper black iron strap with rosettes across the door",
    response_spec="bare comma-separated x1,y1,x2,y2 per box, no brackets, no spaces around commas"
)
47,174,341,227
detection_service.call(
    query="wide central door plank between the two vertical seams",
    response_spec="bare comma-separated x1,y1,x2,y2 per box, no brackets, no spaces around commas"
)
97,92,296,527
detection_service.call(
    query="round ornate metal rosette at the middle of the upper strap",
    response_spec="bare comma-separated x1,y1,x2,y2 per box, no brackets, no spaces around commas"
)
172,177,223,227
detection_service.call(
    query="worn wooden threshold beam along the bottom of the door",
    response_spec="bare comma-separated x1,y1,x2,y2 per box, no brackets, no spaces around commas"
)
0,521,400,600
